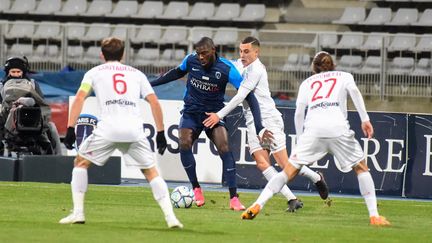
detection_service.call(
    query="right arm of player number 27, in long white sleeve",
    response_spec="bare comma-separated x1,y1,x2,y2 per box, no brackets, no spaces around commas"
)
347,80,374,139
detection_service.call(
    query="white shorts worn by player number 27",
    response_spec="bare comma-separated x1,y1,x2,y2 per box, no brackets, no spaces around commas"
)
290,130,364,172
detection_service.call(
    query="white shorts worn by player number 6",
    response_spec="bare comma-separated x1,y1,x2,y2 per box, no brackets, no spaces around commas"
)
78,133,156,169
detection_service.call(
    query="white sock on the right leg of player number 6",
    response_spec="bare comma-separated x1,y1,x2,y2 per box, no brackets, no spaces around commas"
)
150,176,175,219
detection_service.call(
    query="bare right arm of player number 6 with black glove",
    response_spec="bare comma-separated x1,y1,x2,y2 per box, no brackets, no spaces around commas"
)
146,94,167,154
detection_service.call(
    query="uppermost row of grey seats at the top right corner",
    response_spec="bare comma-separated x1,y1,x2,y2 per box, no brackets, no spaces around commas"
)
332,7,432,26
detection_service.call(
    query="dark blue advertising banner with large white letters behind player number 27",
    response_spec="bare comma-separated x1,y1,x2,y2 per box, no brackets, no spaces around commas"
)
227,108,407,196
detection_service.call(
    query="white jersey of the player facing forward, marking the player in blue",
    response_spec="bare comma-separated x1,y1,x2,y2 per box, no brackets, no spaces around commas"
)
233,58,282,119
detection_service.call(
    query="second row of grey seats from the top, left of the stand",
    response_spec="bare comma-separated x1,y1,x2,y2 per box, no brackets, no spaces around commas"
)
4,21,243,45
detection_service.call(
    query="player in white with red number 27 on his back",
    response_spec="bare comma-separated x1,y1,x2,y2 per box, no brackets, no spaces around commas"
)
241,52,390,226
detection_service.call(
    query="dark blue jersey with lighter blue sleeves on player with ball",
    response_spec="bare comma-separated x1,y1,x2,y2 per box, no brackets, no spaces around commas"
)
179,53,243,112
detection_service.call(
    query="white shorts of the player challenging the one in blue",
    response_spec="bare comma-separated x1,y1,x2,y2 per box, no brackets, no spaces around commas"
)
245,112,286,154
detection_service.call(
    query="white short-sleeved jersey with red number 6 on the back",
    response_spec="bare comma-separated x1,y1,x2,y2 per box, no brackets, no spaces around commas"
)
82,62,154,142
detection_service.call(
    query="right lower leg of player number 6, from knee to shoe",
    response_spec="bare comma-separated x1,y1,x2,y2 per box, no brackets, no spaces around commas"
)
142,167,183,228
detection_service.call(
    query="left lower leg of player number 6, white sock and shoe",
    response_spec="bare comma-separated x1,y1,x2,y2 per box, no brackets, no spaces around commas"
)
59,155,90,224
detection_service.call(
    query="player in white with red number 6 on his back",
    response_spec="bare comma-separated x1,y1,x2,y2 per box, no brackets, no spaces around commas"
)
59,37,183,228
